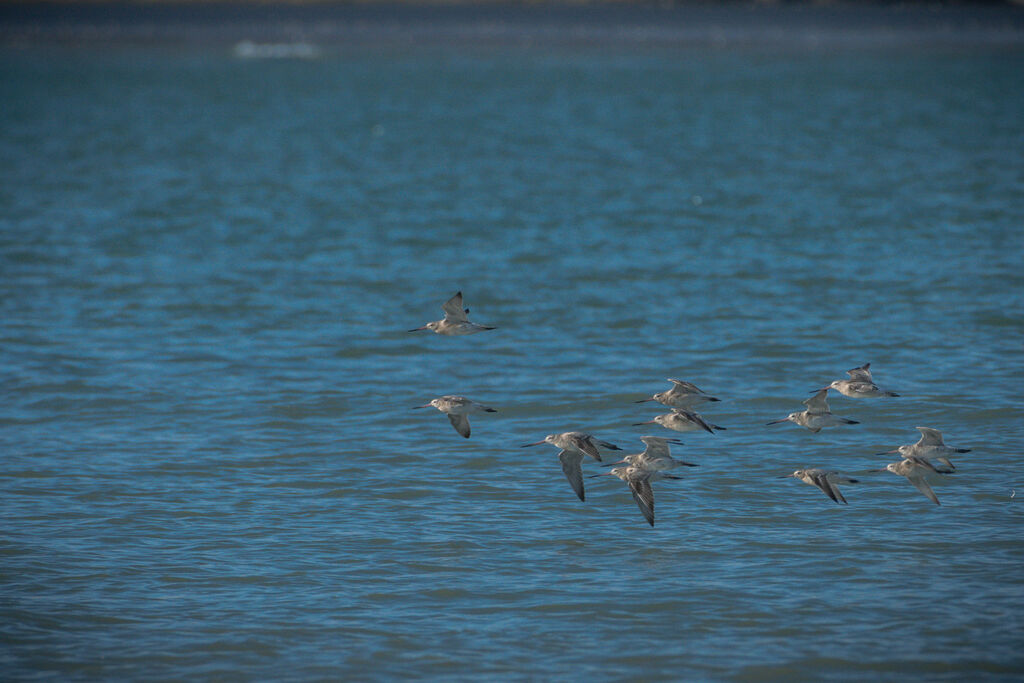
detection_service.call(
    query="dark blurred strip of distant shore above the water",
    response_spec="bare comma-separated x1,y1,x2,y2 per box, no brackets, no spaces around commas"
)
0,0,1024,48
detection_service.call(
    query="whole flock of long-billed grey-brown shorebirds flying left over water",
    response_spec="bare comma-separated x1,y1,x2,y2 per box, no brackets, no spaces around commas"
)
410,292,971,526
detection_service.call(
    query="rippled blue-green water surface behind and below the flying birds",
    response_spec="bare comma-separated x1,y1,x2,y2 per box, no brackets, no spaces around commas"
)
6,38,1024,681
